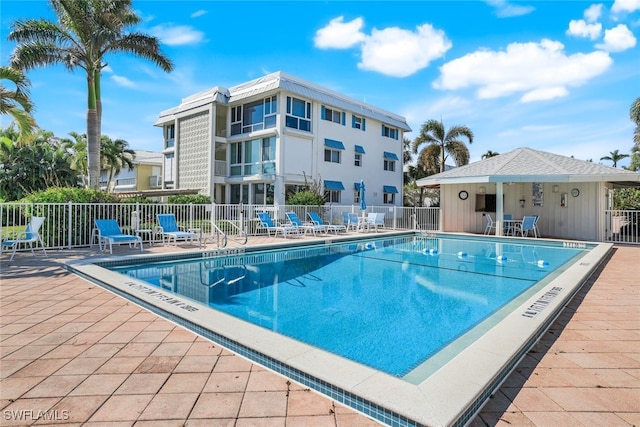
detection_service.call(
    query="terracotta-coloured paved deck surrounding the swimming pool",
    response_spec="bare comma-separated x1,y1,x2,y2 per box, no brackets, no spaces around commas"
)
0,237,640,427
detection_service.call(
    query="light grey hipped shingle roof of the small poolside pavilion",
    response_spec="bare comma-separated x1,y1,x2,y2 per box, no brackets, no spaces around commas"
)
417,148,640,186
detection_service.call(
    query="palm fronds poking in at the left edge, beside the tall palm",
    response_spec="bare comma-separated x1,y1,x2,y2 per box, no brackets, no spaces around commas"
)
0,66,36,138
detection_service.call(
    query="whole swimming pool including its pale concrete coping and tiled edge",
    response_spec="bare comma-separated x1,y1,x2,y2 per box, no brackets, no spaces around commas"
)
67,234,612,425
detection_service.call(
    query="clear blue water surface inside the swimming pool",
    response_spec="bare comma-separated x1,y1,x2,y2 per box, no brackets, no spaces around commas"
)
113,236,584,377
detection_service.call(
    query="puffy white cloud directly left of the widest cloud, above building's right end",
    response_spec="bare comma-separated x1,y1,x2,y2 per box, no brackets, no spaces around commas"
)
358,24,451,77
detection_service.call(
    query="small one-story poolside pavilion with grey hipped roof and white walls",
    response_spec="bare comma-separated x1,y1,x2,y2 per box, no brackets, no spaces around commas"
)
417,148,640,241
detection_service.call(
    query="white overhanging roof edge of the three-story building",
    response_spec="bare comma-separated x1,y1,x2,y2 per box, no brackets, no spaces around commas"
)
155,71,411,132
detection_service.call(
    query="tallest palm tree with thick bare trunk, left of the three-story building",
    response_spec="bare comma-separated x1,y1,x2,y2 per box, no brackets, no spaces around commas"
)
8,0,173,189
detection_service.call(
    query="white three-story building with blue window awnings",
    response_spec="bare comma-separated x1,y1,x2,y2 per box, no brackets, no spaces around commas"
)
155,72,411,206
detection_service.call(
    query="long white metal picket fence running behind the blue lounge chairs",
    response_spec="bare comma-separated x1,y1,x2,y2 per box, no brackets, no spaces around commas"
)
0,202,439,249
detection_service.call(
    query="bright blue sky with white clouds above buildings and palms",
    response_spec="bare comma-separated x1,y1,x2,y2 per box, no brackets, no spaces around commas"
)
0,0,640,166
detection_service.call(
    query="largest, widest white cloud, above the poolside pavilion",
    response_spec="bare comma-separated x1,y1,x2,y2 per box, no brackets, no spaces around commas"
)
433,40,613,102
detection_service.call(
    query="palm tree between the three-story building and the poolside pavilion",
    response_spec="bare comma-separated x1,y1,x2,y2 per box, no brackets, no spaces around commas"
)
413,119,473,172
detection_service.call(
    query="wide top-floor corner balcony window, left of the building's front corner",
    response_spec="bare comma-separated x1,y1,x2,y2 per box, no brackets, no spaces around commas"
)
231,96,278,135
